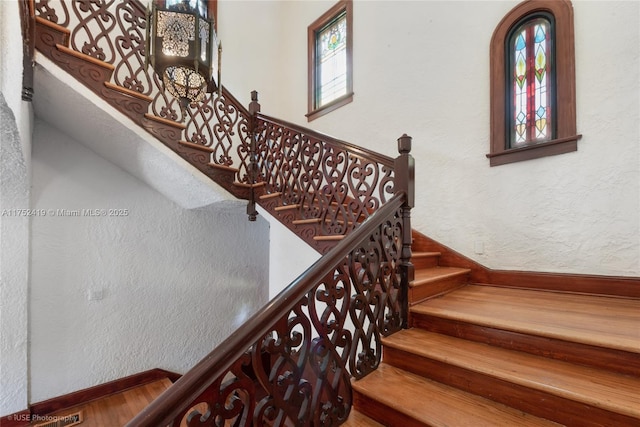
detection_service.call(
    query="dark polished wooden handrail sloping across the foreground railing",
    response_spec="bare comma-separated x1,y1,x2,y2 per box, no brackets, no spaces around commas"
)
127,193,406,427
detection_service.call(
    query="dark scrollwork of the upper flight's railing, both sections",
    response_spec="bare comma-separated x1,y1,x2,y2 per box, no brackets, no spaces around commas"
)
35,0,395,246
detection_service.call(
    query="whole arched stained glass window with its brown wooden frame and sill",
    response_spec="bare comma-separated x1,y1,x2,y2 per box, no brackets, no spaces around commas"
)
487,0,581,166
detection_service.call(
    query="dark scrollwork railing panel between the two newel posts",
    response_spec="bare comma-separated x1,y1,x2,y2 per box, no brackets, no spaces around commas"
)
256,117,395,236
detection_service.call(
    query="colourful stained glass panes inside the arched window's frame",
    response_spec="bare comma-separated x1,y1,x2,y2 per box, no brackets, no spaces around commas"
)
506,15,555,148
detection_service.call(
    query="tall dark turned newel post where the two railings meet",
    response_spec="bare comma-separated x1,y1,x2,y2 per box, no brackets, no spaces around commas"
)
394,133,415,328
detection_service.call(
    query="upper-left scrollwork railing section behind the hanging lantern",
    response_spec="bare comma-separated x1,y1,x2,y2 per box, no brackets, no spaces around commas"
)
35,0,249,174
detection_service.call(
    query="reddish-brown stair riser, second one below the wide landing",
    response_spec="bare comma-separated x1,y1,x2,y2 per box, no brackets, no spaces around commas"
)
383,346,640,427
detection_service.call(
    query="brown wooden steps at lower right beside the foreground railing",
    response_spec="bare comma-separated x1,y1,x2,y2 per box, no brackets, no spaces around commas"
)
347,237,640,426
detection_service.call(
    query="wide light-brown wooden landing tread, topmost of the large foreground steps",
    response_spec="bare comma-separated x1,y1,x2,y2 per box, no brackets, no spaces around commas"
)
411,286,640,353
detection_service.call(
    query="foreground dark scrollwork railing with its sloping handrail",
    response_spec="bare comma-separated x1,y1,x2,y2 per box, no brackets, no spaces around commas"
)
127,193,406,427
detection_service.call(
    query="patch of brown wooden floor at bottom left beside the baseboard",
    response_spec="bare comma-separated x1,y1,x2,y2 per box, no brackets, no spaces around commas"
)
50,378,173,427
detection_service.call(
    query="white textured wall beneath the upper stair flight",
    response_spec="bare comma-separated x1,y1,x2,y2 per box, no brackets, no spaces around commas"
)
30,121,269,402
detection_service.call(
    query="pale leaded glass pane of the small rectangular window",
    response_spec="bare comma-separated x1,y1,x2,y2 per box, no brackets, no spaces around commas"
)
316,13,347,107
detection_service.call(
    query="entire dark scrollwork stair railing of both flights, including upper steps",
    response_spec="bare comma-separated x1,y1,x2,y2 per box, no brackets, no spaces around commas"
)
30,0,414,427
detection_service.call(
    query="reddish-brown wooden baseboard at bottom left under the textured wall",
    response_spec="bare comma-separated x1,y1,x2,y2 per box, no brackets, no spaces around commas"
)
0,369,181,427
